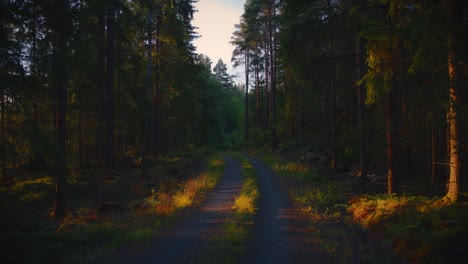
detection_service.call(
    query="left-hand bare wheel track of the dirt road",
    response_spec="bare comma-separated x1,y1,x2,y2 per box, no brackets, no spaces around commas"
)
123,157,242,263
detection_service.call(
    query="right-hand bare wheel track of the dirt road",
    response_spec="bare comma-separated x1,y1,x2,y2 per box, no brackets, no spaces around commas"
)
244,158,333,264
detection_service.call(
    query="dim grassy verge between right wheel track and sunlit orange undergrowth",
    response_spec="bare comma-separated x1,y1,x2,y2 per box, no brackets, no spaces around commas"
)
261,154,390,263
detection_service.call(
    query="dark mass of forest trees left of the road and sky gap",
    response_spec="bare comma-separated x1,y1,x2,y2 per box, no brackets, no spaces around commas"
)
0,0,242,217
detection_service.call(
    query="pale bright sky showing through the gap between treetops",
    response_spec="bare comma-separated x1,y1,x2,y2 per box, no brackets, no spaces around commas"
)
192,0,245,82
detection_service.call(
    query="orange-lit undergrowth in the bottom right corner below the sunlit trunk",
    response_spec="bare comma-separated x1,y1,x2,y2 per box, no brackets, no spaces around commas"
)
348,195,468,263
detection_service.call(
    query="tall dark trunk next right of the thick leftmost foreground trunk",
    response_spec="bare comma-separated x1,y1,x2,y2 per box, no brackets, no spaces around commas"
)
106,0,115,170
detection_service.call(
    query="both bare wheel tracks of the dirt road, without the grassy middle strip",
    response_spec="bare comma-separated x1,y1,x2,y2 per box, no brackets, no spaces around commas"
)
123,157,334,264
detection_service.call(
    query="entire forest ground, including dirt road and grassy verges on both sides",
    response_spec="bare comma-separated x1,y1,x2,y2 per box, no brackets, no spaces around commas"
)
0,153,468,263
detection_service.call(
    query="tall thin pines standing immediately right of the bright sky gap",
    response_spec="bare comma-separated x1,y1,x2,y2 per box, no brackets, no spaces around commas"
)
232,0,279,152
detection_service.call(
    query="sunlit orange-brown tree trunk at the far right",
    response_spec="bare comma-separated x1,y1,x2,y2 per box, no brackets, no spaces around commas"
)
446,0,462,202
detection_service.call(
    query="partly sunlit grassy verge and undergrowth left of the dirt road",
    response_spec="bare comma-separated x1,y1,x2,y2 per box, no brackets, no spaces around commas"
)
0,154,224,263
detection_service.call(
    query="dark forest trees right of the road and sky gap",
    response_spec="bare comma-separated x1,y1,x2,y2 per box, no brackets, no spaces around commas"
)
234,0,468,198
